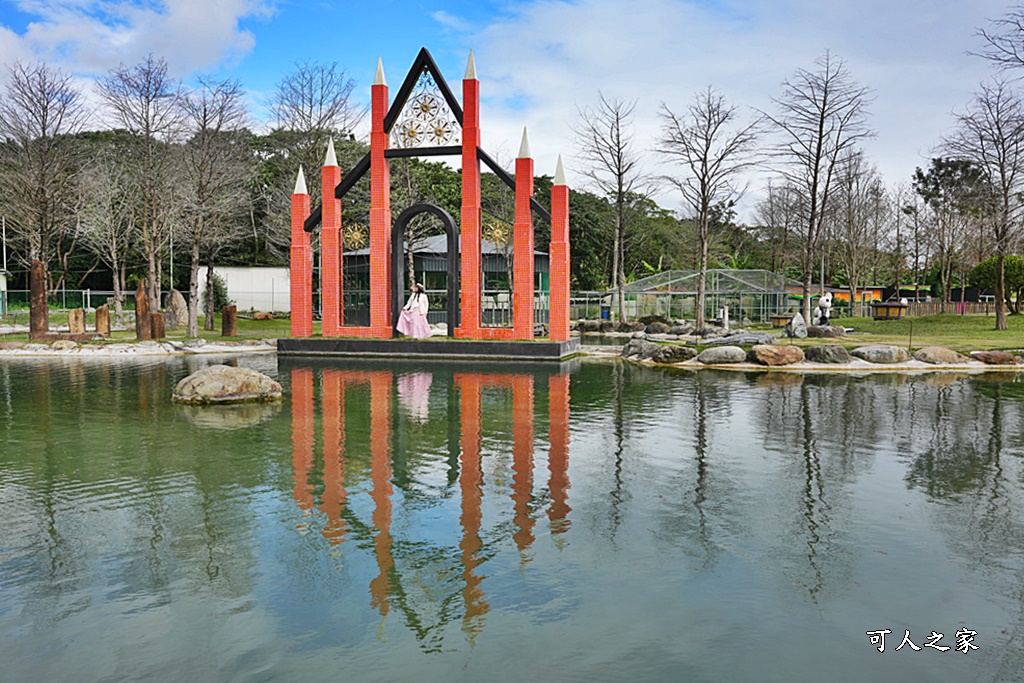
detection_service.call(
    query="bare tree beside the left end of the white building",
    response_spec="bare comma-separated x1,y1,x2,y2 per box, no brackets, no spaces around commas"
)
181,77,253,337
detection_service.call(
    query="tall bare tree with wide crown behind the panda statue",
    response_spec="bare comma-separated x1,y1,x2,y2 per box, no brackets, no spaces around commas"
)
765,52,873,321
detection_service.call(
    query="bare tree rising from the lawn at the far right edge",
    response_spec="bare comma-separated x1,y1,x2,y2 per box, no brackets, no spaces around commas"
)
944,80,1024,330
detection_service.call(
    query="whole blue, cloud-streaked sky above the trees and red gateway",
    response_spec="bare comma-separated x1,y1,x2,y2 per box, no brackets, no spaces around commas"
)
0,0,1011,219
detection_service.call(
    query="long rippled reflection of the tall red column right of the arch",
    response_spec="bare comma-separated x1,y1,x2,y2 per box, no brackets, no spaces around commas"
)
457,375,490,634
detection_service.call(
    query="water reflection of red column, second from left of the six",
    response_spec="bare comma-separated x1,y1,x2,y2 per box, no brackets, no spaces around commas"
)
321,370,346,546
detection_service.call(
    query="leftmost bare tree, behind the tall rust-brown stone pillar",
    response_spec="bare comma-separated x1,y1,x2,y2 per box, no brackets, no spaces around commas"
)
0,61,86,290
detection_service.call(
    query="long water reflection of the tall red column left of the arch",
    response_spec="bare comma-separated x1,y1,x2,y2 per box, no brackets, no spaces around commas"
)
370,372,394,616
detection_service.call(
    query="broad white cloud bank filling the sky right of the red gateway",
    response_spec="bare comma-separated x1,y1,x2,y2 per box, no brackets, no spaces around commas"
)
460,0,1006,218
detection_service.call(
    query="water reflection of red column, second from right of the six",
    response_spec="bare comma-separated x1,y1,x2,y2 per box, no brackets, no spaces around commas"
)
512,375,537,552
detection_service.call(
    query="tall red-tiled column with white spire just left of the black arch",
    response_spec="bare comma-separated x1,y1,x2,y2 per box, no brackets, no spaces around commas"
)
370,62,393,337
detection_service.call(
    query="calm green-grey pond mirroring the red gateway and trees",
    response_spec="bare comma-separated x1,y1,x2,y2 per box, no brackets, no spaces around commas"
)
0,355,1024,682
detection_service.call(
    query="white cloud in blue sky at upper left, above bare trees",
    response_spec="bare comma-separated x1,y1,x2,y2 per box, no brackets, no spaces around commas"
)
0,0,270,77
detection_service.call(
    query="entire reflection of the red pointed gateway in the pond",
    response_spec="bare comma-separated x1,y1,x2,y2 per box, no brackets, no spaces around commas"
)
291,367,571,650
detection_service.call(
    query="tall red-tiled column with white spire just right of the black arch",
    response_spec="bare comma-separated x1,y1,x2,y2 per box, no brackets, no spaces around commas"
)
456,52,483,339
